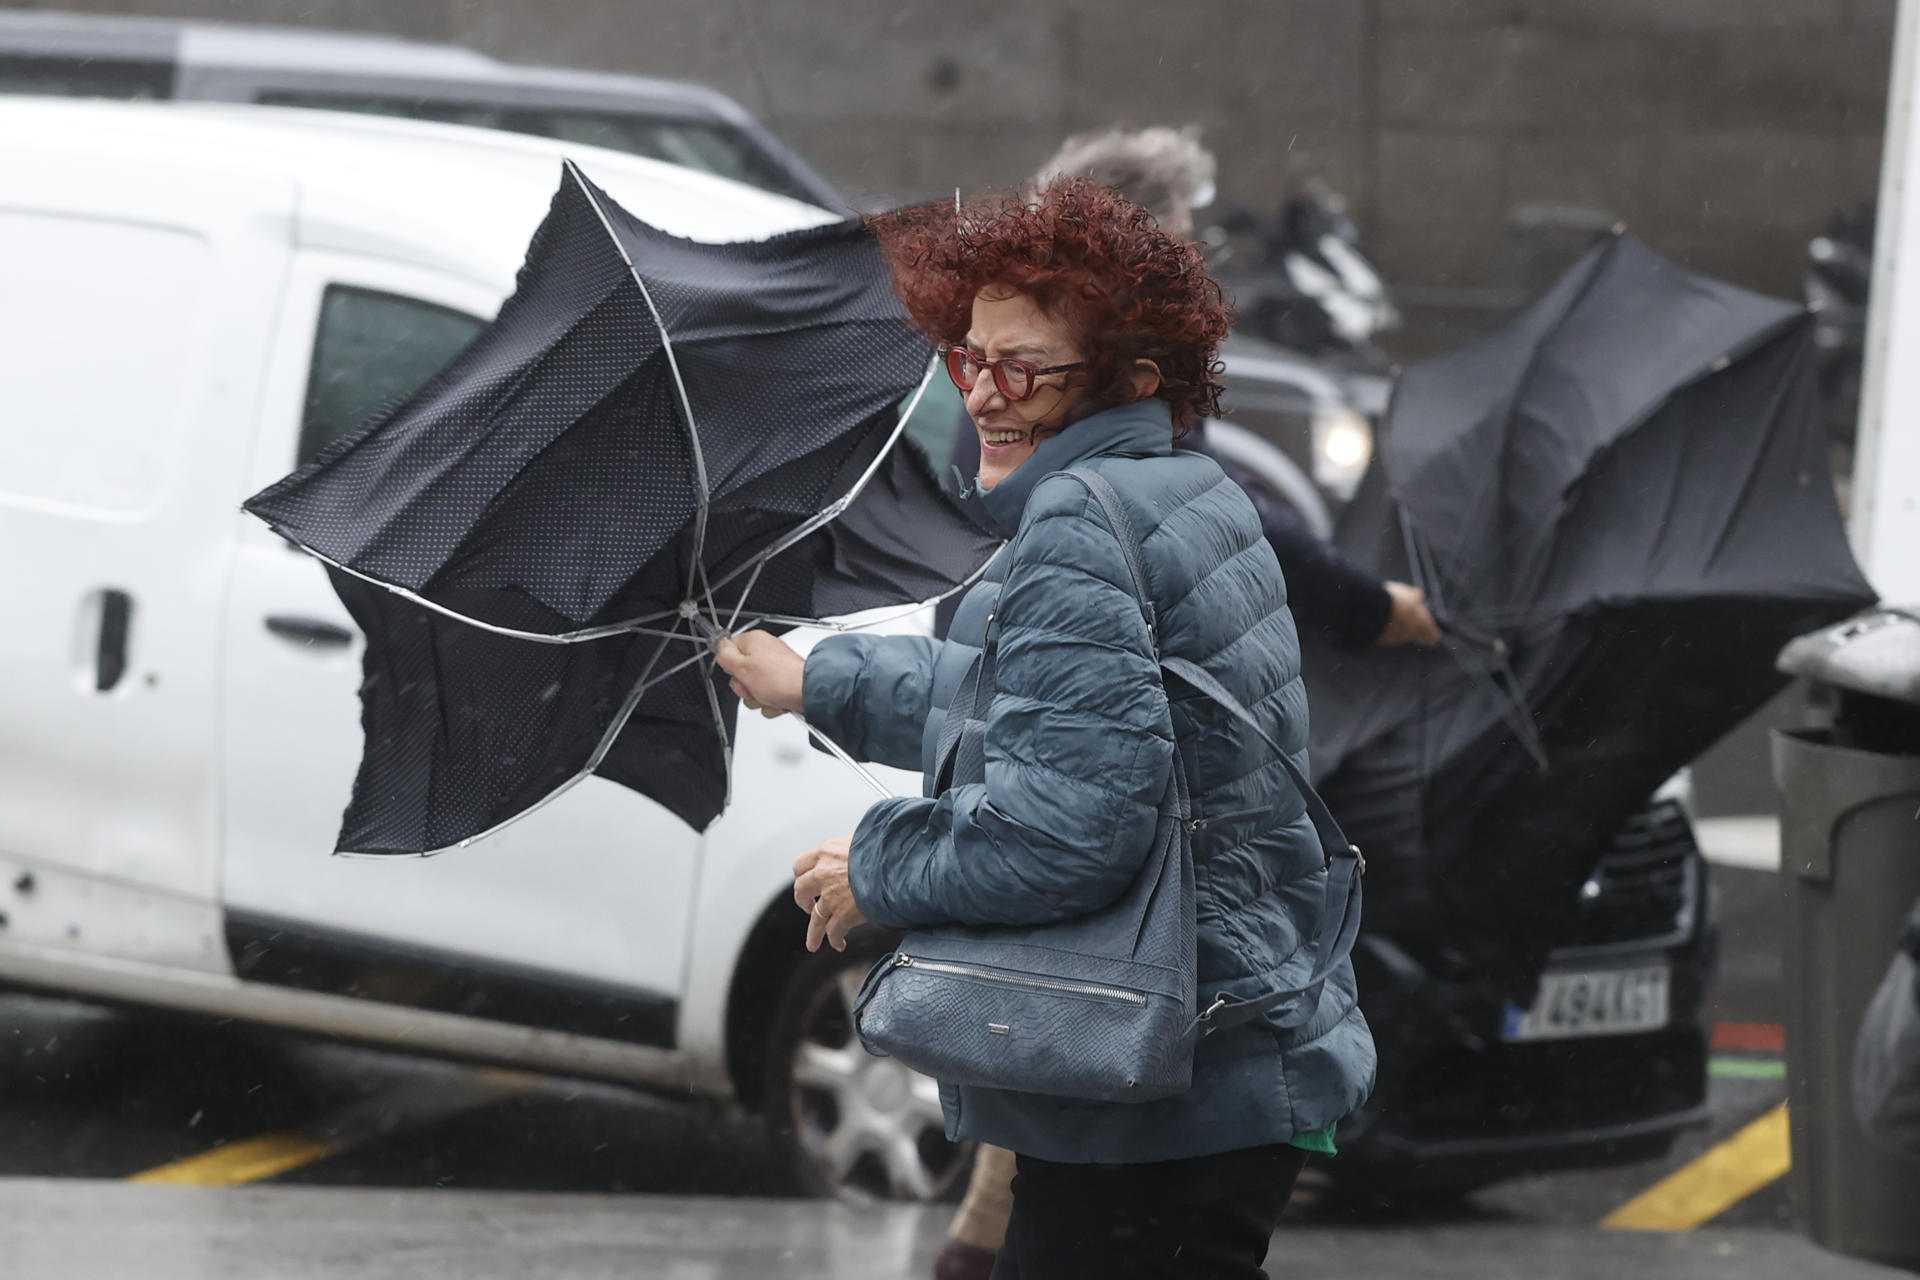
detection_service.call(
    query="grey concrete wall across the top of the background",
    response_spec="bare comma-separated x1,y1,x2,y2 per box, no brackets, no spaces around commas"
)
15,0,1895,326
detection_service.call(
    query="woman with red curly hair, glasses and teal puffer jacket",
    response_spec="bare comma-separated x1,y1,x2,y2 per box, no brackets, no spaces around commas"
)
720,180,1375,1280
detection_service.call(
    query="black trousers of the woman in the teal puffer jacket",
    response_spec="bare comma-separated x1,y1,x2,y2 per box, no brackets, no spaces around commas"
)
993,1146,1308,1280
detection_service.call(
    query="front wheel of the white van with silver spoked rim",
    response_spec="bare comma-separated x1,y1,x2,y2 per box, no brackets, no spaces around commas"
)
762,938,973,1201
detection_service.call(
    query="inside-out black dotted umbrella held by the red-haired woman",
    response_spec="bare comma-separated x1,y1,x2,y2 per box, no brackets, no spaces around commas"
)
246,163,996,852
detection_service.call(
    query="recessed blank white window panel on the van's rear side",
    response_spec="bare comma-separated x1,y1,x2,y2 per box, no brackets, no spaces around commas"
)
0,209,209,510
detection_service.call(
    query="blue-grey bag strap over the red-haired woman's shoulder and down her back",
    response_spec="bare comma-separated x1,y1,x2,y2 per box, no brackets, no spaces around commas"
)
1067,468,1367,1034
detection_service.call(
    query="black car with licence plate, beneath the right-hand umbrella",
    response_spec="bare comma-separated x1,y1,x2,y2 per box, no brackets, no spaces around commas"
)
1332,791,1715,1197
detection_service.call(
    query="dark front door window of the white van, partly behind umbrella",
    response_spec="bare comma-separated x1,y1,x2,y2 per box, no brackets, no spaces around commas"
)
298,284,486,462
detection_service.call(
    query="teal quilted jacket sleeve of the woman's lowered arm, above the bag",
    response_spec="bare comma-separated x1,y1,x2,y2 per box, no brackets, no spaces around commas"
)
851,476,1173,929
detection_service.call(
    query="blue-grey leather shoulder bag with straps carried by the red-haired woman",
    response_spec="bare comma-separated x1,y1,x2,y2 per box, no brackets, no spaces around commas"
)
854,468,1365,1102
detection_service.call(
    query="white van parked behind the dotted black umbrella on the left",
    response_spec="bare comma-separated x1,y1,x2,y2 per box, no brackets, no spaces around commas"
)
0,98,966,1197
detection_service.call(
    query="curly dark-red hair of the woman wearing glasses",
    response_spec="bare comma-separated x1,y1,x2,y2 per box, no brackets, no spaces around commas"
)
868,178,1229,434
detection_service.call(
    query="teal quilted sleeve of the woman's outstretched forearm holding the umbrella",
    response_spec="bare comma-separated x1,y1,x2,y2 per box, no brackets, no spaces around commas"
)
801,635,939,770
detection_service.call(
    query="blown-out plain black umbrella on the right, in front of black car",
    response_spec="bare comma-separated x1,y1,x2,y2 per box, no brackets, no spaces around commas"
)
1308,234,1872,977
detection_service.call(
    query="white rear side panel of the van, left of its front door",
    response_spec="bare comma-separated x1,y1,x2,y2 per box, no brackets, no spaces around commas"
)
0,144,294,960
